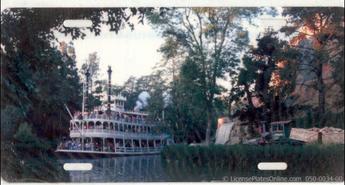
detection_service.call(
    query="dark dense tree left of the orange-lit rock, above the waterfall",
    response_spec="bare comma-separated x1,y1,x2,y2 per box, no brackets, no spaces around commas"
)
238,31,299,122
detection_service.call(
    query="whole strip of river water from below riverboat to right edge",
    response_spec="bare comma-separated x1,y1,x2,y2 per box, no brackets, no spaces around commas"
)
59,155,343,182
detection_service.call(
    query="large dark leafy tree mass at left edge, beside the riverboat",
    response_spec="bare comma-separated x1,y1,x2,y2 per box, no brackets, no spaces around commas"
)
1,29,81,138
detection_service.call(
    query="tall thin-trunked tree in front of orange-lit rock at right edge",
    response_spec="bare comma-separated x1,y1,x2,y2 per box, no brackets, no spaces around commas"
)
281,8,344,123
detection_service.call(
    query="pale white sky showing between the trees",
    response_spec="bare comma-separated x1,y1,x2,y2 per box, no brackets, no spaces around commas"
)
57,8,285,85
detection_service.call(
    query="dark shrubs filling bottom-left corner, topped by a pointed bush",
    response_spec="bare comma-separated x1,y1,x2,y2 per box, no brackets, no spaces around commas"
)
1,123,69,182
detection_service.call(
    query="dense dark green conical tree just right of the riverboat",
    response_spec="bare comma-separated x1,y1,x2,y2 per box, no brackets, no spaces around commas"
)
165,60,207,143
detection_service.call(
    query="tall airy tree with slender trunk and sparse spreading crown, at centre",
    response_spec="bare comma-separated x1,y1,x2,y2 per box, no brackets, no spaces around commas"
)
149,8,258,143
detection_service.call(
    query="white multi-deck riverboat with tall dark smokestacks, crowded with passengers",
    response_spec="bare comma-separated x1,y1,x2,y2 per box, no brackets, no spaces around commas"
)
56,68,172,155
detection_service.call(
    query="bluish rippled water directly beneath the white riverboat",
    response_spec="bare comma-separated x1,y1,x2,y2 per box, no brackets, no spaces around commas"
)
60,155,167,182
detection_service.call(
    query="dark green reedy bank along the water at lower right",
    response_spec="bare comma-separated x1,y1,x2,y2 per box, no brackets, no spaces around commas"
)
161,145,344,181
